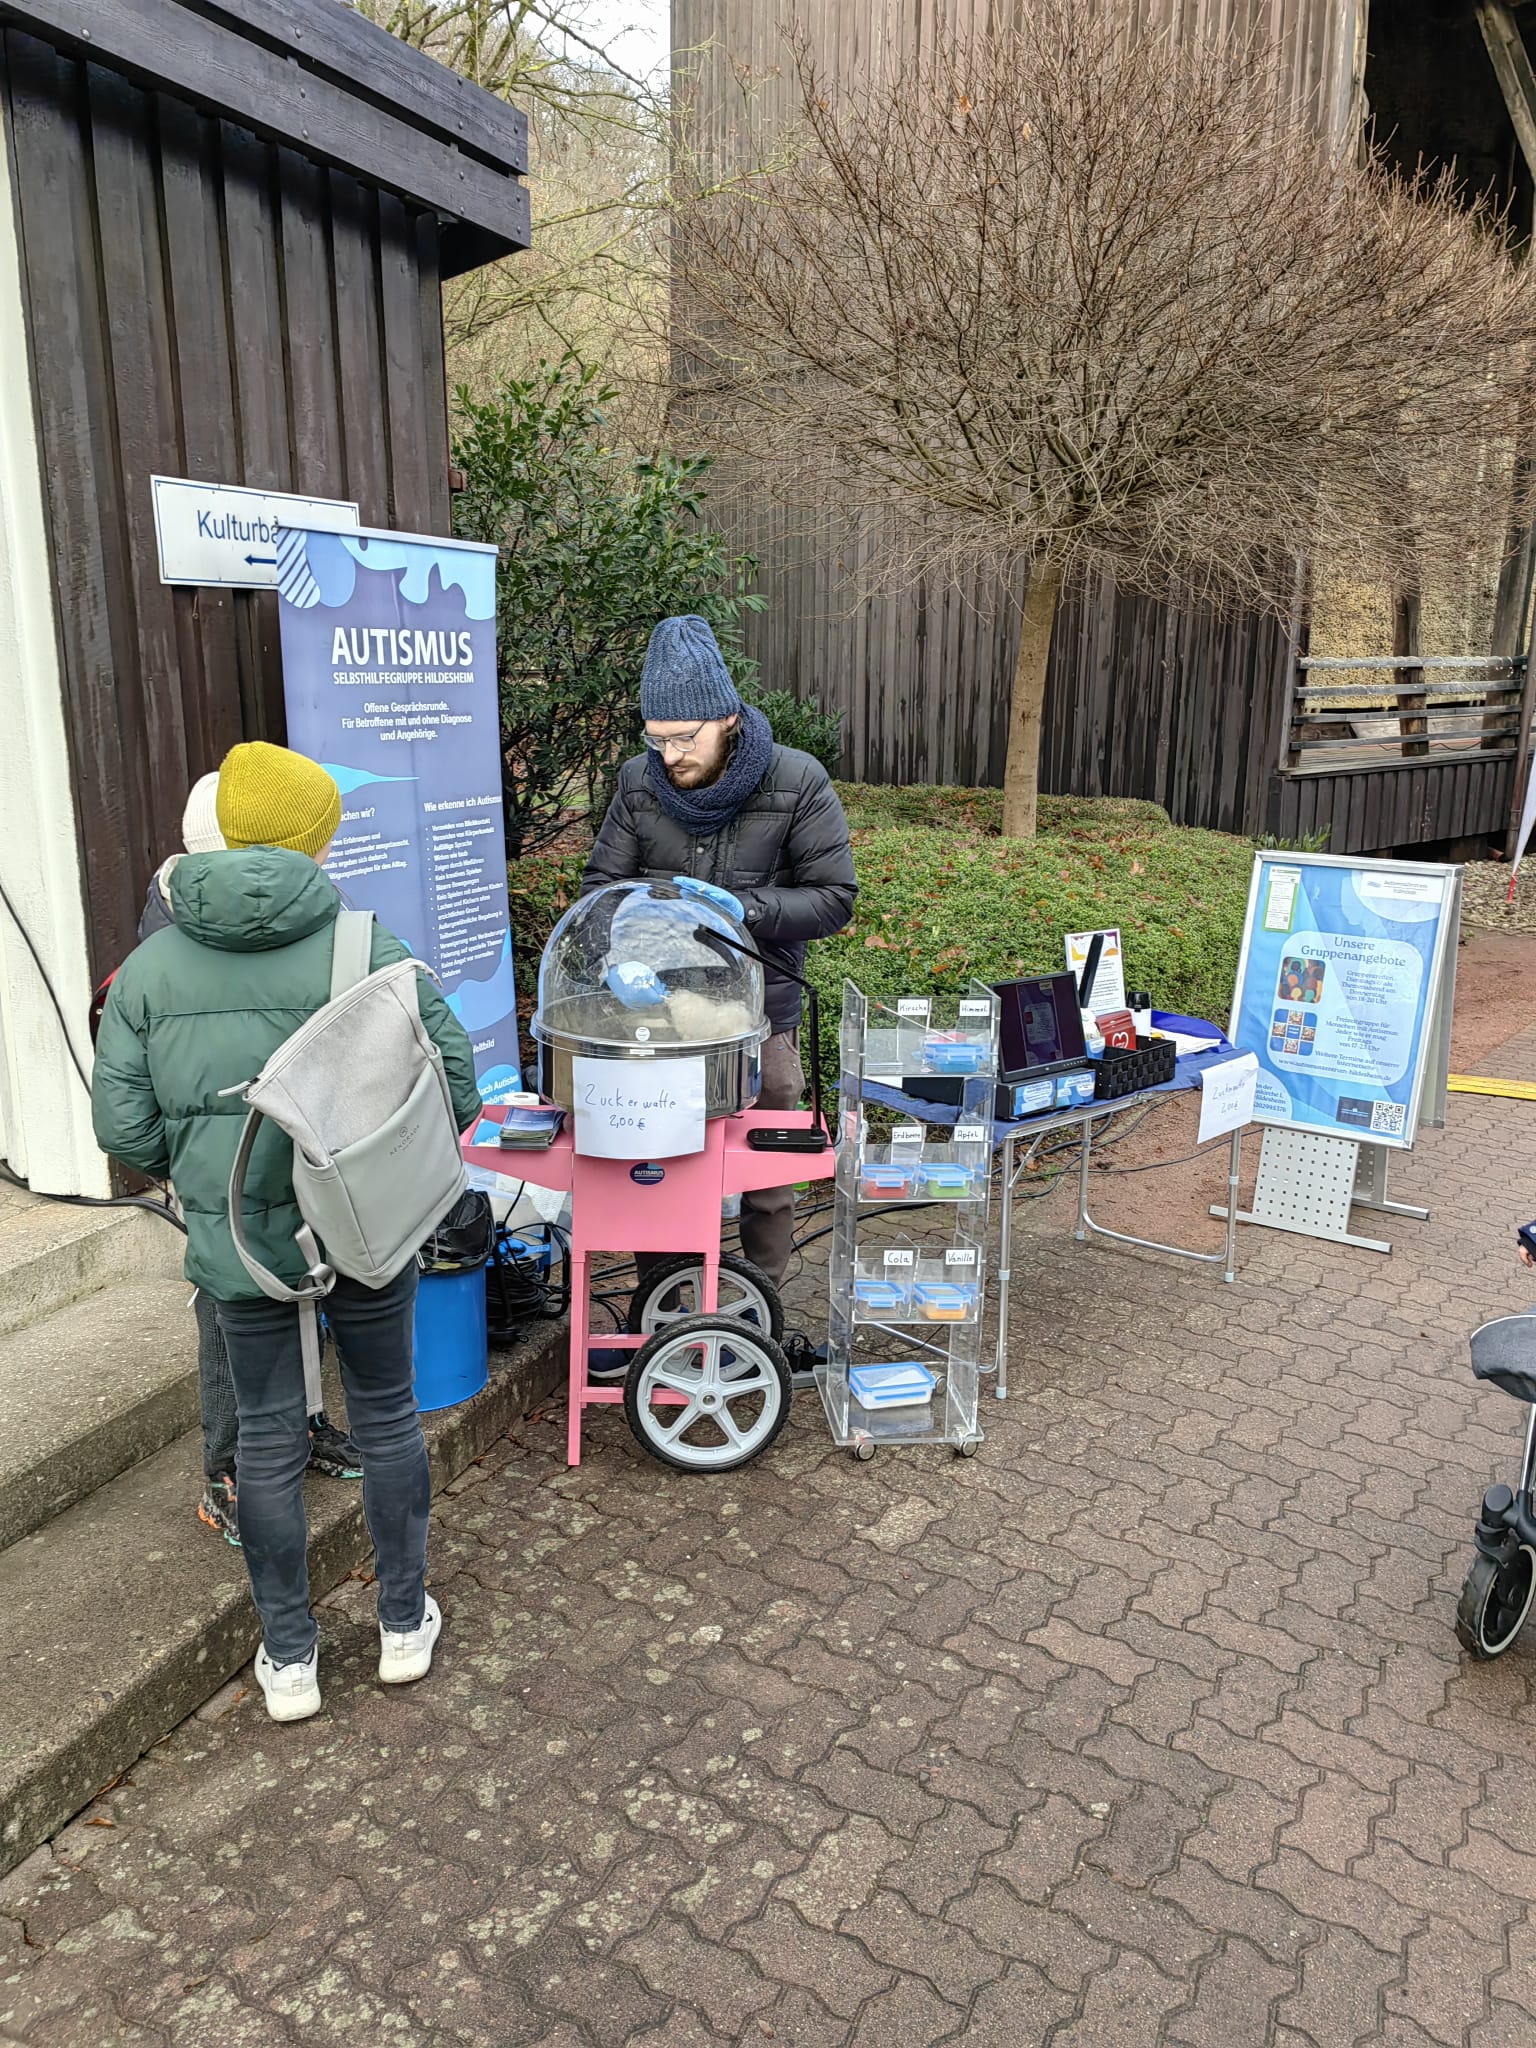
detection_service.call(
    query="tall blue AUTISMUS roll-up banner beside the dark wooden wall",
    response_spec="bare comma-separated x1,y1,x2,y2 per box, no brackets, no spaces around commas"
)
276,526,522,1102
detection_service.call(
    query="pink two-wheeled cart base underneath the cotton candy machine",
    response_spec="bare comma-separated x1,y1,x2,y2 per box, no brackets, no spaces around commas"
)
465,1108,836,1473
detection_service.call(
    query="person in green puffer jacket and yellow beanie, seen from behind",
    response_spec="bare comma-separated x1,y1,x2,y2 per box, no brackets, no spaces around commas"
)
92,741,481,1720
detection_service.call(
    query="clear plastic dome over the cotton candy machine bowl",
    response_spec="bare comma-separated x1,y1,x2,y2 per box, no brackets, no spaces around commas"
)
532,883,768,1057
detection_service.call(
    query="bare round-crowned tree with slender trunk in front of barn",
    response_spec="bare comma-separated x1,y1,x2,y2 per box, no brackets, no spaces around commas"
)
674,0,1536,836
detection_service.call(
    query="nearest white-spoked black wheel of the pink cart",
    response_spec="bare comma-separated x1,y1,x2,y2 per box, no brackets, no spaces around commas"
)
625,1315,791,1473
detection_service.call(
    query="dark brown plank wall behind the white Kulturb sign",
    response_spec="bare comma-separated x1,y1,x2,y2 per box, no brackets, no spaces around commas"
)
0,31,449,973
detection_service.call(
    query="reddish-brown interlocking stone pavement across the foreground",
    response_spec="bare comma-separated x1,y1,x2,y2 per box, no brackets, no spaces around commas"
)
0,1032,1536,2048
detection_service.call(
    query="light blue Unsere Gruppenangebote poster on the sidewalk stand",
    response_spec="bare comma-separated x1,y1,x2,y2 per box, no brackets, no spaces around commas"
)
1229,852,1458,1147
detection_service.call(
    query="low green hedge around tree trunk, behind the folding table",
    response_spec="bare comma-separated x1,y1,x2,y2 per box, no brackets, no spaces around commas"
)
512,784,1253,1073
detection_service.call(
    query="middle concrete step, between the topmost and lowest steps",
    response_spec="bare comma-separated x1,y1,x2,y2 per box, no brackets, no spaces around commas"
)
0,1269,197,1548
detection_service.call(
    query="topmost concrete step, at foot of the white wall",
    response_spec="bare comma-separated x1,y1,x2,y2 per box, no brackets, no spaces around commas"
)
0,1190,186,1335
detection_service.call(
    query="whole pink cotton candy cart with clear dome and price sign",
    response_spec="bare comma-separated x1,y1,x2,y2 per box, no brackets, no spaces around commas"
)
465,877,834,1473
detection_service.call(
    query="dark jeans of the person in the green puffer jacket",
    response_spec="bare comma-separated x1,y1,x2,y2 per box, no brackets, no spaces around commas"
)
219,1260,432,1665
